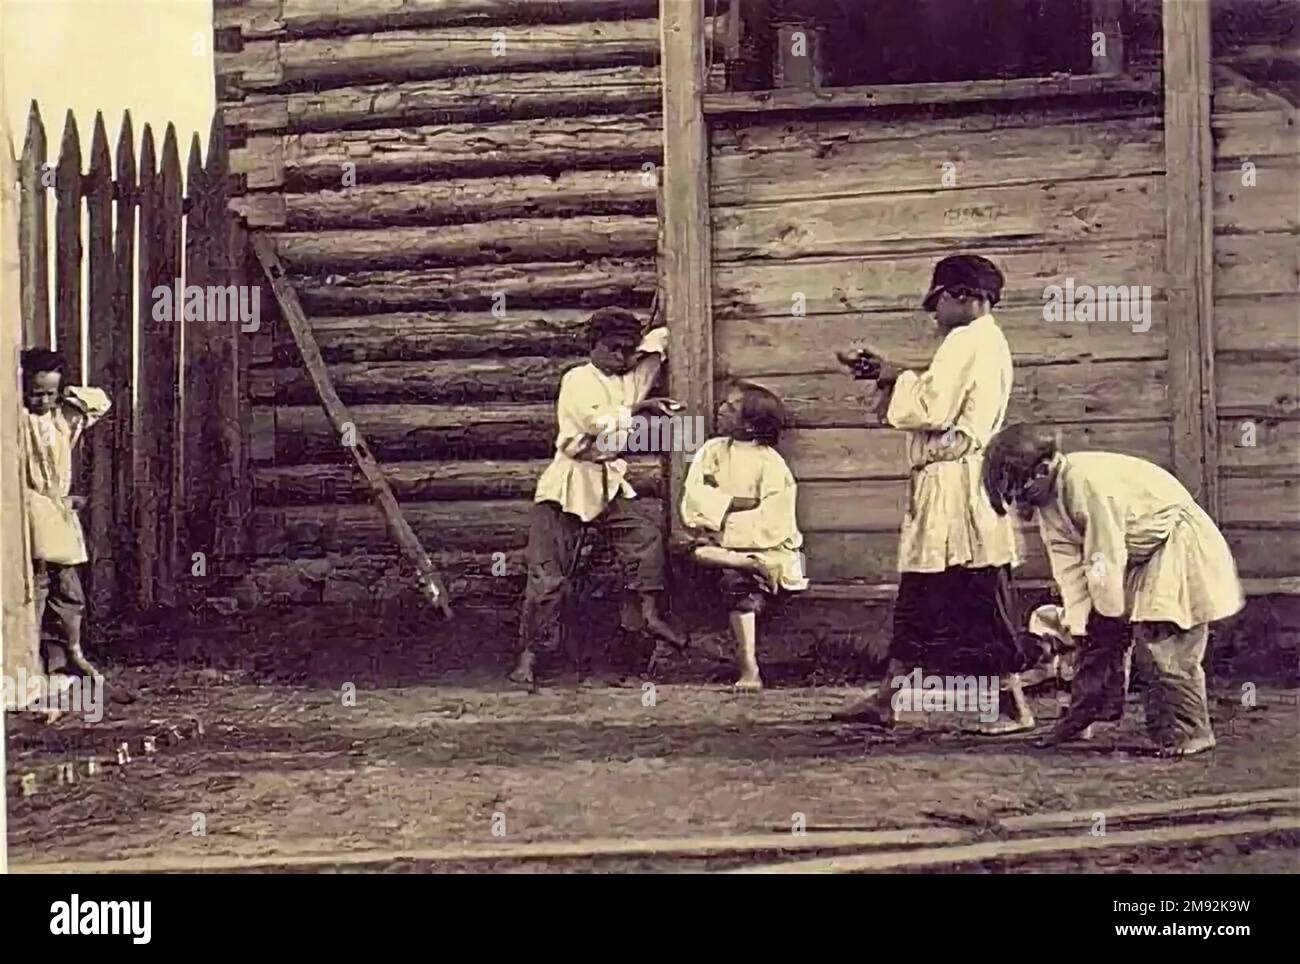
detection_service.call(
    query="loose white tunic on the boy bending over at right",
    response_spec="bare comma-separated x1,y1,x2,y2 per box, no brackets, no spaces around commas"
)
1036,452,1244,635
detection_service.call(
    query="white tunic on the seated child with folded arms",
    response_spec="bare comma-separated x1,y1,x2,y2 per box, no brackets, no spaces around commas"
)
681,437,809,591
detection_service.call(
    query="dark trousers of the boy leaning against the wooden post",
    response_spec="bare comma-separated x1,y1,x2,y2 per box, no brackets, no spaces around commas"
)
519,498,664,651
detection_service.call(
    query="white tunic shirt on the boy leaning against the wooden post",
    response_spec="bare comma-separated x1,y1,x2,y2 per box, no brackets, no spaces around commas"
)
533,327,668,522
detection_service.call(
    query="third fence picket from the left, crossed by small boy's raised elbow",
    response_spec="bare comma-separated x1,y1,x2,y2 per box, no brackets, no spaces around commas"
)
82,113,121,610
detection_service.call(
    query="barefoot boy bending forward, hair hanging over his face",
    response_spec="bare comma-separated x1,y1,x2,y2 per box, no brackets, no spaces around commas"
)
984,425,1244,756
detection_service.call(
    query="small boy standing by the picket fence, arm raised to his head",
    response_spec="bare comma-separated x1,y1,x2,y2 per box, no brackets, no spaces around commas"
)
22,348,111,677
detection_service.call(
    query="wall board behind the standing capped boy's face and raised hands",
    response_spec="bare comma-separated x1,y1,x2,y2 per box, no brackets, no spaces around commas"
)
714,301,1167,377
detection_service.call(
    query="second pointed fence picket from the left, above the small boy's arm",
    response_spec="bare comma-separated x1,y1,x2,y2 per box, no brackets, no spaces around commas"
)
55,109,86,381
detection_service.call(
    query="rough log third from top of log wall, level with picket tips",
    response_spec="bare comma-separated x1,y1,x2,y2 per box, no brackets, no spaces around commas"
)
222,66,660,134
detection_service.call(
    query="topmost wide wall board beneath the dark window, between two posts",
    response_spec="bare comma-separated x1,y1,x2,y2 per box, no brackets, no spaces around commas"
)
710,112,1164,207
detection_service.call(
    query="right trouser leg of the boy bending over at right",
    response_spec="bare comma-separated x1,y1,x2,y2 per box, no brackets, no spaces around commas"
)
1134,622,1214,747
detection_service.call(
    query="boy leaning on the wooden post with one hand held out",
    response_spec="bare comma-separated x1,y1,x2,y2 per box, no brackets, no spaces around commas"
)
510,308,685,686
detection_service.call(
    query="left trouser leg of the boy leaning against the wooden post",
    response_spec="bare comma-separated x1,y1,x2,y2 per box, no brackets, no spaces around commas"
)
519,501,582,651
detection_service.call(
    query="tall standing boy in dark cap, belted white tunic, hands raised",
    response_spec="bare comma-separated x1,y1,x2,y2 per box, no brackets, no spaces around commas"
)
836,255,1034,731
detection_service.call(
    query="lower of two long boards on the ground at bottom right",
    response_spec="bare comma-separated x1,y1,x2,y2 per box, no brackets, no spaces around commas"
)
728,817,1300,874
